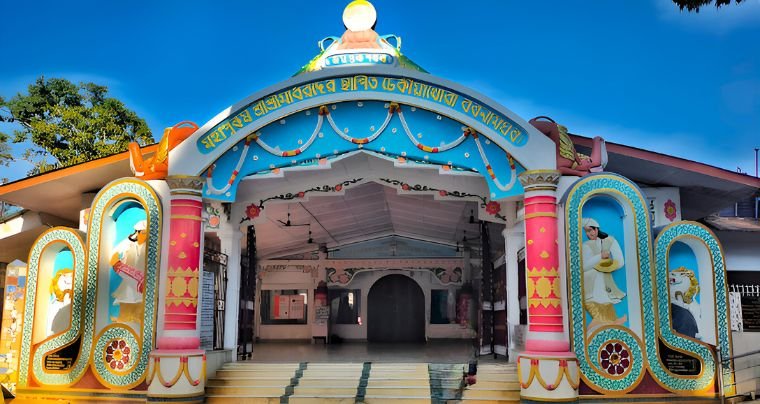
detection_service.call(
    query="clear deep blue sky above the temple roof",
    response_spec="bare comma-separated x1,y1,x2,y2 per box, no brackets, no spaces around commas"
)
0,0,760,179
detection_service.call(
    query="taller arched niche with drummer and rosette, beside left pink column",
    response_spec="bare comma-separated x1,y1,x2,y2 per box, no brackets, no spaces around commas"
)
82,178,162,389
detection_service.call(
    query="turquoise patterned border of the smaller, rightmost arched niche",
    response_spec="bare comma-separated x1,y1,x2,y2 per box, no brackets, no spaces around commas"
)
653,222,733,390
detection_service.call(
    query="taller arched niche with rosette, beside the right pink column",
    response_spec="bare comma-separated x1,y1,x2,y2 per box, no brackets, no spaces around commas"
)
560,173,654,395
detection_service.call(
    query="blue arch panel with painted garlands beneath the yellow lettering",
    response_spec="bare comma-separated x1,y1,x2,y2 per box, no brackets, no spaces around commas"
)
204,101,525,201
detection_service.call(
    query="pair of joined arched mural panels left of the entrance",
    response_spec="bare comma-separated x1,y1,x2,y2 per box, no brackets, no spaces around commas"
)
19,179,161,389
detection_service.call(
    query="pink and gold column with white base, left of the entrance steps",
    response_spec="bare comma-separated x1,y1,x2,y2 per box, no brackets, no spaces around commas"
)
146,176,206,402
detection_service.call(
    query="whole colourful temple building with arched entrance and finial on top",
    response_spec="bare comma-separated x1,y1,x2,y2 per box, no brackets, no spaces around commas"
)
0,0,760,403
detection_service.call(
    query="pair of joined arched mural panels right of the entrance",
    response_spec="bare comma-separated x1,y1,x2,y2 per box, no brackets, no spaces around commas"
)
564,174,732,396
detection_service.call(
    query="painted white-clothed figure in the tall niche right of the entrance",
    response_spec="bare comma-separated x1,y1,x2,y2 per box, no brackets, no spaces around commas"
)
582,218,628,331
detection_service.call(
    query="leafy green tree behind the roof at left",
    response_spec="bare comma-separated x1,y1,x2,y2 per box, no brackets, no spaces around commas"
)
0,77,153,175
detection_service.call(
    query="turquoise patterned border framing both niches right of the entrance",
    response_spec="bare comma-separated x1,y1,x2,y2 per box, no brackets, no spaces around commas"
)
564,173,730,395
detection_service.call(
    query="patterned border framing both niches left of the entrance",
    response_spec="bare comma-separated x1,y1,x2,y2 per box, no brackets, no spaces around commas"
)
19,178,162,388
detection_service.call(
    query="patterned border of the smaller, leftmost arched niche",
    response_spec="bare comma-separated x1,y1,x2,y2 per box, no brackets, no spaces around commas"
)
18,227,89,388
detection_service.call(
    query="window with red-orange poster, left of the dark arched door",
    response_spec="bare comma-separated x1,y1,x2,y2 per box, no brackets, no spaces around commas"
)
261,289,308,324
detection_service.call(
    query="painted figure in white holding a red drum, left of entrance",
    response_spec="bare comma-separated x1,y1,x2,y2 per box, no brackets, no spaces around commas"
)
111,220,148,324
